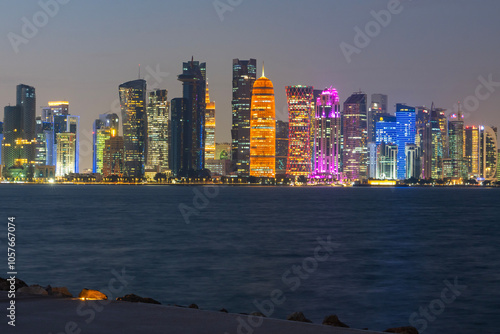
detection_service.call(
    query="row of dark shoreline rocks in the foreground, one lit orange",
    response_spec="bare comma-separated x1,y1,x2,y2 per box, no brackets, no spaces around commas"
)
0,277,419,334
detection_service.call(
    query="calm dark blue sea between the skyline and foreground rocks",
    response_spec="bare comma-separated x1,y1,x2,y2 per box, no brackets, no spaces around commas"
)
0,184,500,333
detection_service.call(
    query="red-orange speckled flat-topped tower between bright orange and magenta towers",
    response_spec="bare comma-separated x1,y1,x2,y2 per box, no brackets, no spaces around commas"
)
286,86,314,177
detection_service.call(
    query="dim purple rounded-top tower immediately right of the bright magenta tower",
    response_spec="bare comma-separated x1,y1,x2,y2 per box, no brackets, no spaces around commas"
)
342,93,368,180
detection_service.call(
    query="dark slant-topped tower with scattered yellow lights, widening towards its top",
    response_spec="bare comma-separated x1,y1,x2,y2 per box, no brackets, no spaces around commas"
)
119,79,147,178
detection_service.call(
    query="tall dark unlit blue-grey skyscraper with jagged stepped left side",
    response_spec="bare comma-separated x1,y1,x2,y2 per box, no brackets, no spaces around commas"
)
176,60,206,176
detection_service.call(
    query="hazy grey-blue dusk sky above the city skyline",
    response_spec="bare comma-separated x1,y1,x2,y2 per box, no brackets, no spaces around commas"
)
0,0,500,170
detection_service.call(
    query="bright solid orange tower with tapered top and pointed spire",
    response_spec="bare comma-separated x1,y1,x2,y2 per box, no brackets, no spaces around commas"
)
250,65,276,177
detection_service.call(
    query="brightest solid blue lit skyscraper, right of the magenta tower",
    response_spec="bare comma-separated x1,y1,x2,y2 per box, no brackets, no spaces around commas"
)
396,103,416,180
